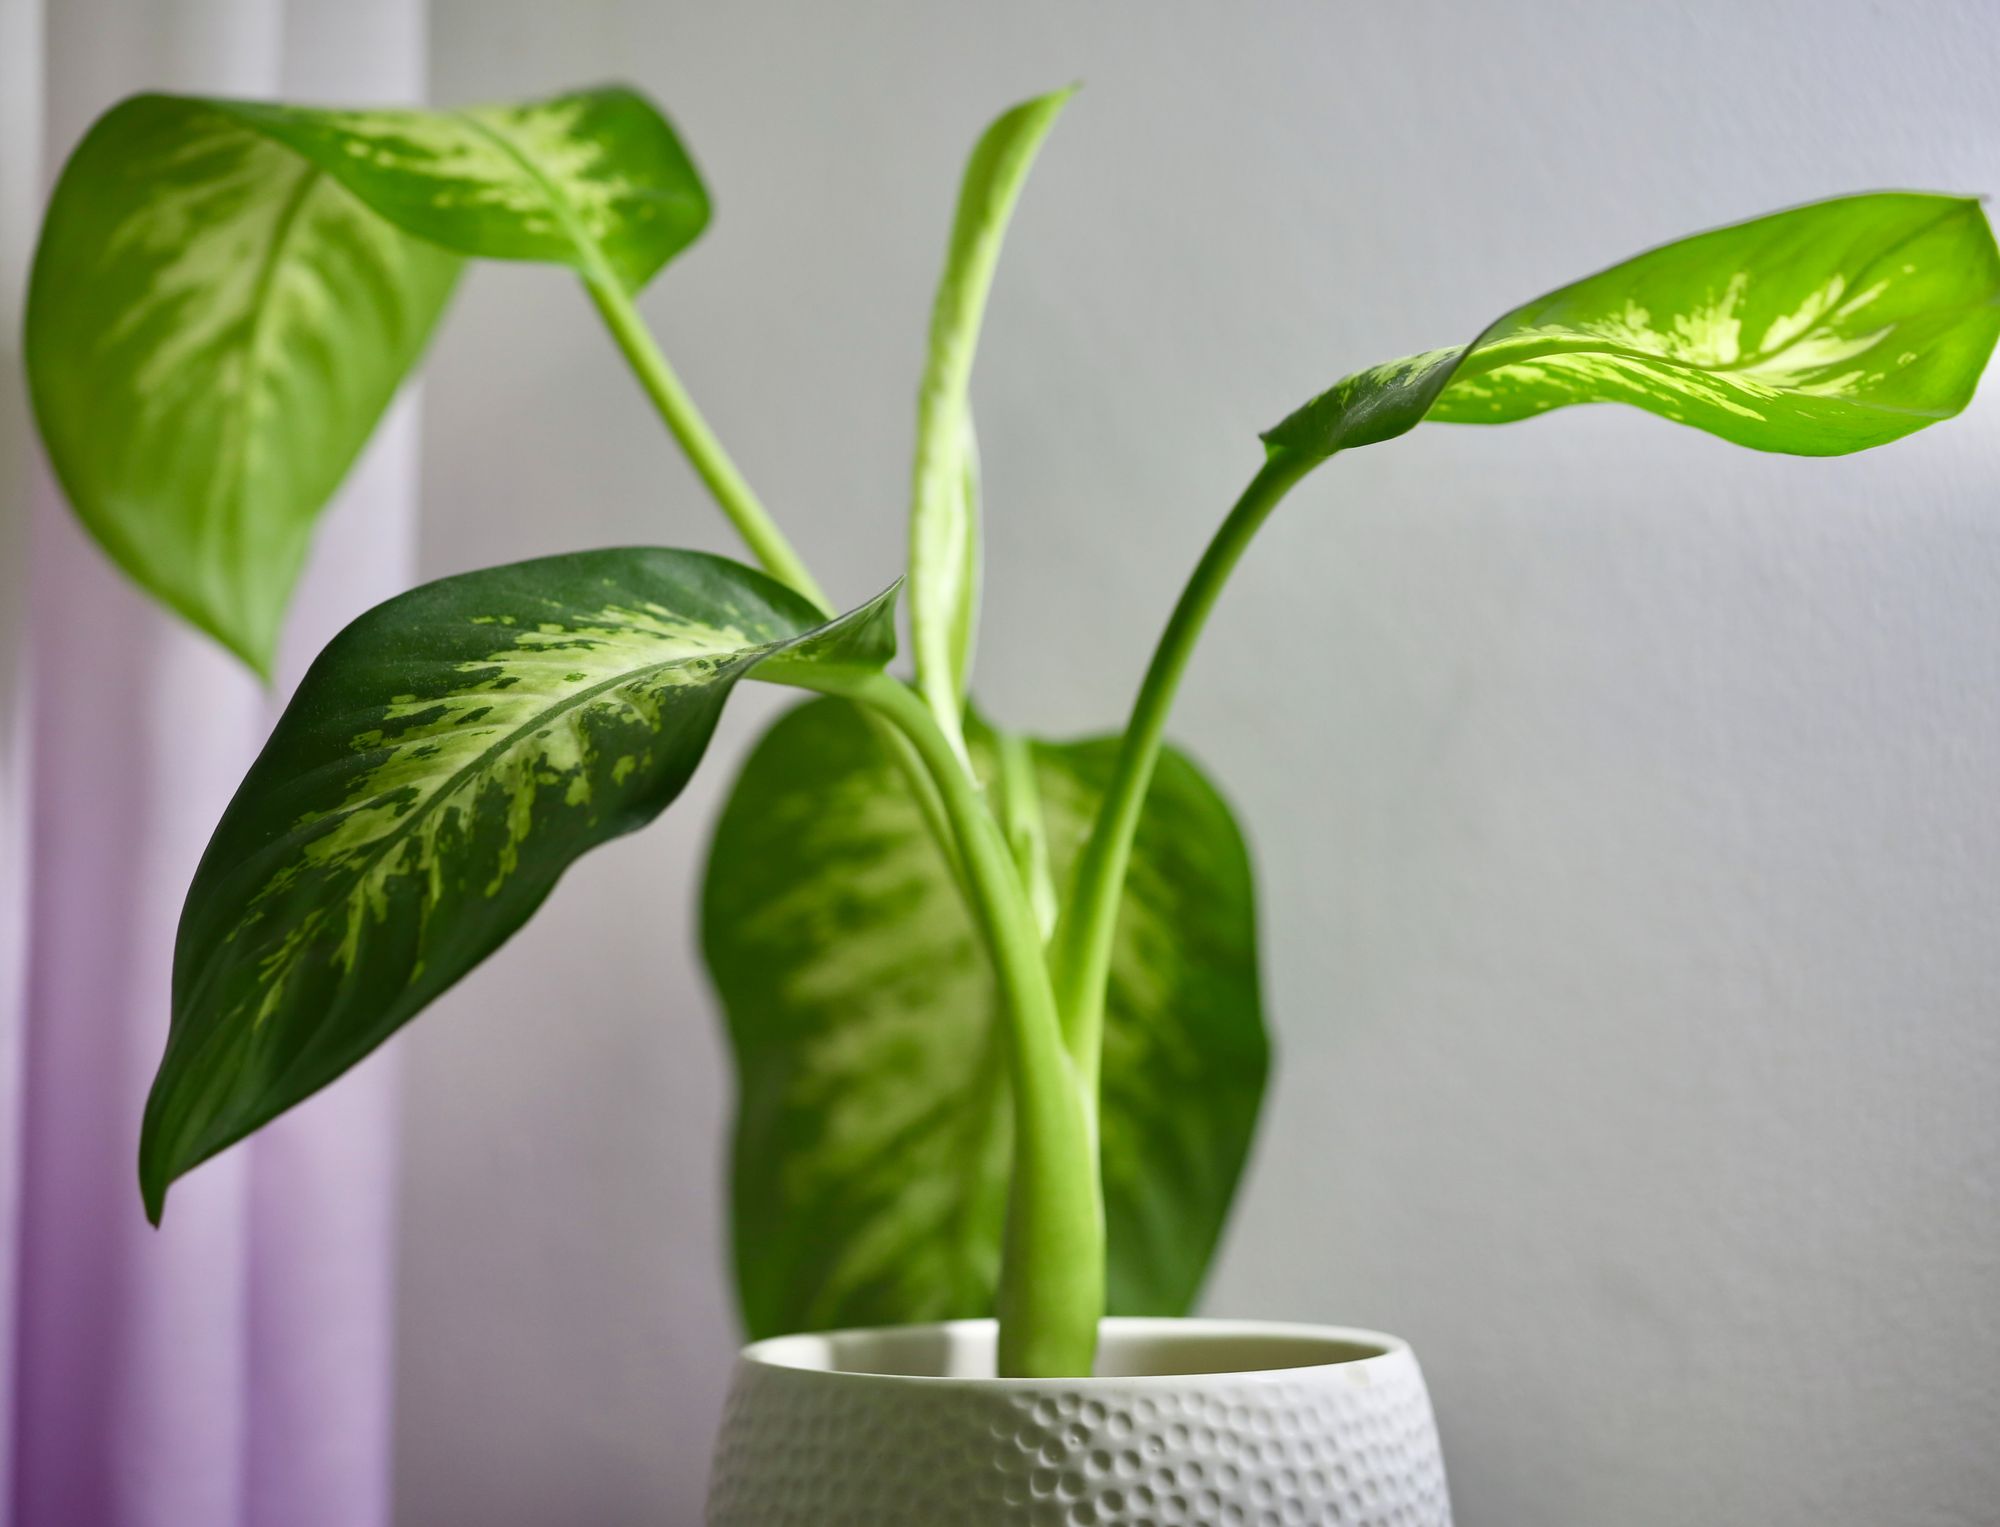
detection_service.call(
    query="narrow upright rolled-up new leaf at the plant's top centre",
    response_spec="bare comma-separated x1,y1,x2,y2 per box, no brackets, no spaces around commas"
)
910,88,1076,746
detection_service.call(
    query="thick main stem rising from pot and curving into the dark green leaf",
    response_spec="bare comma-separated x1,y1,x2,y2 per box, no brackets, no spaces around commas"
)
772,666,1104,1379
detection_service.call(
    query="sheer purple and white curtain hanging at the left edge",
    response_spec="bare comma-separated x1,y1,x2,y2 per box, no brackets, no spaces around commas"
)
0,0,424,1527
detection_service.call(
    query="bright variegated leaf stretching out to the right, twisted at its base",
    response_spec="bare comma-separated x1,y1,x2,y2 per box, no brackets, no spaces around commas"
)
1264,192,2000,458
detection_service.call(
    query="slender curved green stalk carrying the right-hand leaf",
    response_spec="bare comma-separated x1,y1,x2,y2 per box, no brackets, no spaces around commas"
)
1050,450,1320,1097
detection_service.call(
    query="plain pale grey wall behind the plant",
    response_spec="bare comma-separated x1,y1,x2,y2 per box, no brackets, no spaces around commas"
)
400,0,2000,1527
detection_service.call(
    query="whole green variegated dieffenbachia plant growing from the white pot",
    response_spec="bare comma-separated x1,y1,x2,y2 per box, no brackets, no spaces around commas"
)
26,77,2000,1375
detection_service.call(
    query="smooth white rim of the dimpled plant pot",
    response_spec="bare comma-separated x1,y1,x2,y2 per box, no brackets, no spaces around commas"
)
738,1315,1410,1391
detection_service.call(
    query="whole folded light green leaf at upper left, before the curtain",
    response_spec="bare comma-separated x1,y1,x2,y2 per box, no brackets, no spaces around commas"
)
26,90,708,674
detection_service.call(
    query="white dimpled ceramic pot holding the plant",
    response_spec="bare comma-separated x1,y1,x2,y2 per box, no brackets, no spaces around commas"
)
708,1319,1452,1527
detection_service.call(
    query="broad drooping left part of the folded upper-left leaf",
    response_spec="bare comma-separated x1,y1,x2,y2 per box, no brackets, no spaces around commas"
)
26,96,460,674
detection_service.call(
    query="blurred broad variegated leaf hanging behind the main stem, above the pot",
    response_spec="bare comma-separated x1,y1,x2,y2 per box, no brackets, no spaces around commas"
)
702,700,1268,1335
